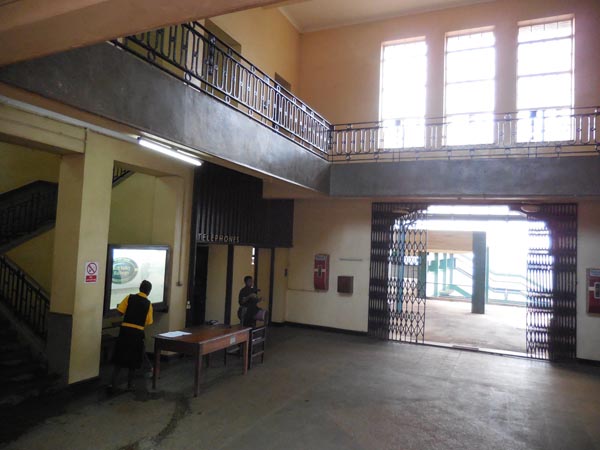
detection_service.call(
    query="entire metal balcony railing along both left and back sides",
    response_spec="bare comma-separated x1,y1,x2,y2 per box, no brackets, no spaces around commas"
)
113,22,600,163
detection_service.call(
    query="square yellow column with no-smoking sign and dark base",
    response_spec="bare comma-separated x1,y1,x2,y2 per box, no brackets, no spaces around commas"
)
48,135,113,384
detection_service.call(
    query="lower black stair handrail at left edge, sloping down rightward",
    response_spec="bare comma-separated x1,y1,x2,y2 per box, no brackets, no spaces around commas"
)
0,255,50,340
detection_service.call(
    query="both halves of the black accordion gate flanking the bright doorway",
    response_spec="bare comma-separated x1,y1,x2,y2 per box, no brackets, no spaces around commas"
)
368,203,577,360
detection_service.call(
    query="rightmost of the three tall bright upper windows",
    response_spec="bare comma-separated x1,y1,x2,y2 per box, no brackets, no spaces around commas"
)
517,19,573,142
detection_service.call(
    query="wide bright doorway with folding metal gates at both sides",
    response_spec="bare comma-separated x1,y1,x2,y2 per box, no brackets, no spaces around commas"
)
368,203,577,360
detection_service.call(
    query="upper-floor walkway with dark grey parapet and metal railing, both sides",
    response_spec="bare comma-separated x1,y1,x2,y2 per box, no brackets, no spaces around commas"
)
0,22,600,197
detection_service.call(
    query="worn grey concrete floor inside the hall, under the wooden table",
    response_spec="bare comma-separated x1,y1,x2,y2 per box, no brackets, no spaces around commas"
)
0,327,600,450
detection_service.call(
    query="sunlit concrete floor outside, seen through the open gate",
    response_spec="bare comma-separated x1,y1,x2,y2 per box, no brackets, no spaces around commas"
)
425,298,527,353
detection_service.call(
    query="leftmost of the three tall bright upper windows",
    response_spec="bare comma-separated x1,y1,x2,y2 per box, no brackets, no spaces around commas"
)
380,38,427,148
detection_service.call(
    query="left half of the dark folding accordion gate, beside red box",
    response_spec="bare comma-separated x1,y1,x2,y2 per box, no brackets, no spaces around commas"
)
369,203,427,342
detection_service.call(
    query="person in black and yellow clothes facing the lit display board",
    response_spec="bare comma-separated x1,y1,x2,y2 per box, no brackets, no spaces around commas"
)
108,280,153,392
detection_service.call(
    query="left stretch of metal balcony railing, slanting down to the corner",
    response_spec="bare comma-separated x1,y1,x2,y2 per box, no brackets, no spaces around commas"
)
113,22,331,158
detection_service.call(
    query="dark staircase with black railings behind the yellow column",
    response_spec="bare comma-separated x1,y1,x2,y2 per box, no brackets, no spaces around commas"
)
0,168,133,407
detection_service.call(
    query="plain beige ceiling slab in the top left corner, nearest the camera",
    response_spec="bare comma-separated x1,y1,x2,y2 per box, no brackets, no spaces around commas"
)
0,0,280,66
